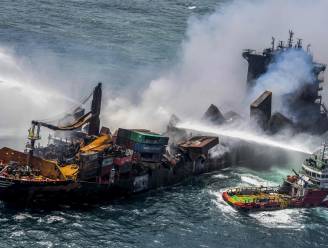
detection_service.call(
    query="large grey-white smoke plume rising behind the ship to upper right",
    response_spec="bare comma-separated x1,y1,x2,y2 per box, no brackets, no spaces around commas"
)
106,0,328,130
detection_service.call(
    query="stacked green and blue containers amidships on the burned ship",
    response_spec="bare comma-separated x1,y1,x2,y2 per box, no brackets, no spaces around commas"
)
116,128,169,162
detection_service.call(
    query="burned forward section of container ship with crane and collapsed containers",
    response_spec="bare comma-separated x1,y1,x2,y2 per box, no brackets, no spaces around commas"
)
0,84,224,205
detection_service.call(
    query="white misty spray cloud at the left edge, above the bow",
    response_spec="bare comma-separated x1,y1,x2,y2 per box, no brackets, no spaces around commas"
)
0,47,96,149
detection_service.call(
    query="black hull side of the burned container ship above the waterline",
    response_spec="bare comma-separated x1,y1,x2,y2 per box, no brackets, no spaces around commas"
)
0,160,227,207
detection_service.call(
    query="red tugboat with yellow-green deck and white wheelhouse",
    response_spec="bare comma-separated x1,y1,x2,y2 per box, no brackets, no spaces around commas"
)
222,144,328,211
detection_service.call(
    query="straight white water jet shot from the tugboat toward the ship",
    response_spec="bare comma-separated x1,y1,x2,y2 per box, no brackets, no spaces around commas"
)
176,122,312,154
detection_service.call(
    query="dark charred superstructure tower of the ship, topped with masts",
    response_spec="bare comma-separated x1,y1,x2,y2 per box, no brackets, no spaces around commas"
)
242,31,328,134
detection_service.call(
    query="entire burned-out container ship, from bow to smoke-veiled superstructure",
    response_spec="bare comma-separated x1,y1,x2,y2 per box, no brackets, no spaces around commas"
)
0,32,328,208
